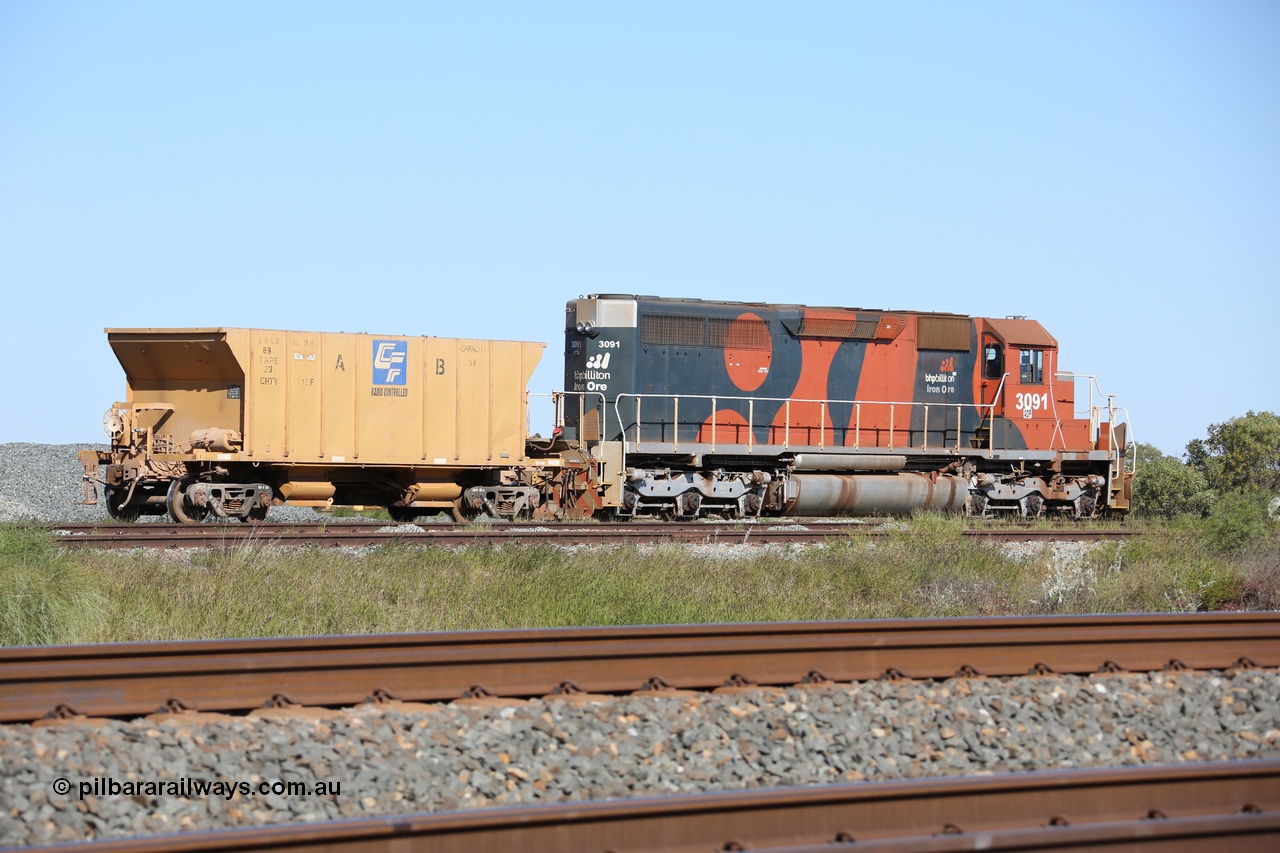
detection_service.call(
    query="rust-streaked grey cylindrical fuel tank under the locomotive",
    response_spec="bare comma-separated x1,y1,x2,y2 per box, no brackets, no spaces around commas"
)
782,474,969,516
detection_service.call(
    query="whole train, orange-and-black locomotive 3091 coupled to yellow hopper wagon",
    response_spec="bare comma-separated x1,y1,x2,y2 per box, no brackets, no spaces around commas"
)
81,295,1133,521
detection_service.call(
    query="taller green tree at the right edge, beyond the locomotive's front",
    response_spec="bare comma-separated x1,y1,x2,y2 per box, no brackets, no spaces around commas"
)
1187,411,1280,494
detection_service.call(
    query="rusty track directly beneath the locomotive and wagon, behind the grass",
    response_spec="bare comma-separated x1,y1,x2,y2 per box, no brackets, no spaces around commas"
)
30,521,1134,548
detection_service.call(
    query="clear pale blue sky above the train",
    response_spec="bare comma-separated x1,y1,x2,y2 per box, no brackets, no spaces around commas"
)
0,0,1280,453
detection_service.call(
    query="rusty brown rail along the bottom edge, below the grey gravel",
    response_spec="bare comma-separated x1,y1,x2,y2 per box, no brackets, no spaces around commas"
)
5,761,1280,853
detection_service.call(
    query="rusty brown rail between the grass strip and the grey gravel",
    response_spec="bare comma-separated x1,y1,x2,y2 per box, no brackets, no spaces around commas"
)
0,612,1280,721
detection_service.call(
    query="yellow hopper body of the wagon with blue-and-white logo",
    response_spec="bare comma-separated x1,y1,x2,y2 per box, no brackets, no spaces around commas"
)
109,329,544,467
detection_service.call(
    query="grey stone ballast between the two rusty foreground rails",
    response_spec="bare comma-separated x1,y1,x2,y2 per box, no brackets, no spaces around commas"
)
0,670,1280,845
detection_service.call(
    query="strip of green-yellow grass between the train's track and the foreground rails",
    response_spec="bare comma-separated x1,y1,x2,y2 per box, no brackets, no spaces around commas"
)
0,515,1280,644
